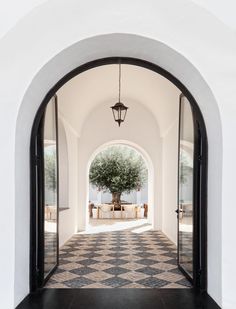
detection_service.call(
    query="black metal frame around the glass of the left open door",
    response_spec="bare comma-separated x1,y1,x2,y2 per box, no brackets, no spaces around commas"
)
30,95,59,291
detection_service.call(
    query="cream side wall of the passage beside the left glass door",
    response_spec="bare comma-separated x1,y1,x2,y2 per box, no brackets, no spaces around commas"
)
58,117,78,246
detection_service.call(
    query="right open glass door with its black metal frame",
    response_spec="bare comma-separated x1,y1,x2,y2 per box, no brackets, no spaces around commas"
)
176,95,206,290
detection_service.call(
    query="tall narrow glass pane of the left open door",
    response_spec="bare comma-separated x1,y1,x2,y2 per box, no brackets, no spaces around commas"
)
43,100,58,279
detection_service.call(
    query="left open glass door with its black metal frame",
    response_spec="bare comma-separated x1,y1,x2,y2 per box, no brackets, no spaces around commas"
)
31,96,59,290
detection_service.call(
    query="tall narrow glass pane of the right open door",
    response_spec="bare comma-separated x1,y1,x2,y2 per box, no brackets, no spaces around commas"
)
178,96,194,279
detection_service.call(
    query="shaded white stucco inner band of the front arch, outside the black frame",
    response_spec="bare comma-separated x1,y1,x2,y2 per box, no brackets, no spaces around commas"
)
12,34,222,306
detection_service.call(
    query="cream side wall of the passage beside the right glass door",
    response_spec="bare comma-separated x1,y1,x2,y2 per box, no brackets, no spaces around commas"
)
162,119,178,244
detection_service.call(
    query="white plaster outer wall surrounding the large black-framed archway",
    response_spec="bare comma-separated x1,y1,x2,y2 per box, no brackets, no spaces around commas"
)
0,0,236,309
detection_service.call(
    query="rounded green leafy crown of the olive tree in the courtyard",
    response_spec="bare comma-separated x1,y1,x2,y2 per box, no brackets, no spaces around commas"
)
89,146,147,193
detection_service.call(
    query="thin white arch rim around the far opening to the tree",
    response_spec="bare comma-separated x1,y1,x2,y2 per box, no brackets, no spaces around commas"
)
86,140,155,226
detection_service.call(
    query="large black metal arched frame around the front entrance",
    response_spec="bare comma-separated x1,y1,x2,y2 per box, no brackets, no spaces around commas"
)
30,57,208,291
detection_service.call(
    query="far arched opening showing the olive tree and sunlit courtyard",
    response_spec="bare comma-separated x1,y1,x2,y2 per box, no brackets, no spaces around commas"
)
86,140,153,231
